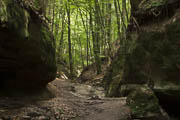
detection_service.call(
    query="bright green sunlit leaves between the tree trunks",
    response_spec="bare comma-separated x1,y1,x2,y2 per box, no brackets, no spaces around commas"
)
46,0,130,73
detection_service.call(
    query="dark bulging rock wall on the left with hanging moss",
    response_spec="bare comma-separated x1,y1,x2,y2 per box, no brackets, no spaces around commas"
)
0,0,56,88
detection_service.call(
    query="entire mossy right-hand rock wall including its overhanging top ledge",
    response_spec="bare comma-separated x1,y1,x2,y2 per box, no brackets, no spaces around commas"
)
104,0,180,119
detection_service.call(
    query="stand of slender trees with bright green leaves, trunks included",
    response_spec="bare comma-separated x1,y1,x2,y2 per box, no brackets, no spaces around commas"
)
43,0,130,76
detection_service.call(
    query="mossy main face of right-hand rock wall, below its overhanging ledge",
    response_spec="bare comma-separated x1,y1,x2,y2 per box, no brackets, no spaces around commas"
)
104,0,180,99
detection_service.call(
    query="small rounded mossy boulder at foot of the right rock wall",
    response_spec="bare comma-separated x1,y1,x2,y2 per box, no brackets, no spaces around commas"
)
126,86,170,120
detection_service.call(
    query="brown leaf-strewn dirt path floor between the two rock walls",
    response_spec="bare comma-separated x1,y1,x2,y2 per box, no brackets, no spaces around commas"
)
0,79,130,120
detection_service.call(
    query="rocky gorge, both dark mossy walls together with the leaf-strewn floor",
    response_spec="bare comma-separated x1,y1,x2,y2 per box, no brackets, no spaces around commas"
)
0,0,180,120
